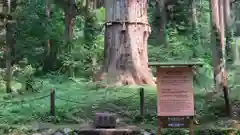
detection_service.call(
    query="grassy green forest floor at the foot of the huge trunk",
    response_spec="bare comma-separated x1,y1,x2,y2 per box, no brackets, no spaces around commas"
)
0,77,240,134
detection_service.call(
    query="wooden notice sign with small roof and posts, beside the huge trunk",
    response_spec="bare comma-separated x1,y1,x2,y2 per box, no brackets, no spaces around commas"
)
150,63,203,135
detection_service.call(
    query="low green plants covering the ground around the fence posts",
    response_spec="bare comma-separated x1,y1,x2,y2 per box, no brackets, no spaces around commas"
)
0,77,235,135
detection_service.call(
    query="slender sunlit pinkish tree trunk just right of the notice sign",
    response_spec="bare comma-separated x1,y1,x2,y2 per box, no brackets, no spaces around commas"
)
211,0,230,113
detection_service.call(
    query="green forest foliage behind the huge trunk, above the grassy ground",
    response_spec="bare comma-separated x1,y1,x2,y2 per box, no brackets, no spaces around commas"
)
7,0,214,86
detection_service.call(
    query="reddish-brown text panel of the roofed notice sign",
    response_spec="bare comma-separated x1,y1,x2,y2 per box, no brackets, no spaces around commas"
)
157,67,194,116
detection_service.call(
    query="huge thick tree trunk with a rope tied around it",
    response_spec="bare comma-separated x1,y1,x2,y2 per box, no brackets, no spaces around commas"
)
103,0,154,85
